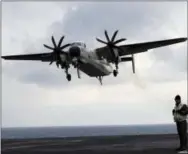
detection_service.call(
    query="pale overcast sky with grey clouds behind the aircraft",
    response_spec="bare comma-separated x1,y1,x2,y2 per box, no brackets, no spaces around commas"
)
2,2,187,127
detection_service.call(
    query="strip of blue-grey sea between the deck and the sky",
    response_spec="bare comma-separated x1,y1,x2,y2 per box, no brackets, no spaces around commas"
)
1,124,177,139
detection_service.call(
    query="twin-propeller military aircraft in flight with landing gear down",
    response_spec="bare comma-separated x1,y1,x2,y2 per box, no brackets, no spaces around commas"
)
1,30,187,85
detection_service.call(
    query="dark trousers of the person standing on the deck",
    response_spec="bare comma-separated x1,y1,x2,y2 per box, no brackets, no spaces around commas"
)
176,120,187,148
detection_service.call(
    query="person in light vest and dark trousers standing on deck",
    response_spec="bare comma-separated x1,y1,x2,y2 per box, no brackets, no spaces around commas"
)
172,95,188,153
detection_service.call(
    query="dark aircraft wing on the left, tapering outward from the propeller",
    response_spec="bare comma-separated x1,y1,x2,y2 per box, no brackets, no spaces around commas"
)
1,53,52,62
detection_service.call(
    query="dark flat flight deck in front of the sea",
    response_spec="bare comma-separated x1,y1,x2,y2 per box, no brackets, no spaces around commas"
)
1,134,184,154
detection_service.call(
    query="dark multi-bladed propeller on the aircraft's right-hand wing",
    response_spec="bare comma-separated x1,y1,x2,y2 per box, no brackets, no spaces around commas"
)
96,30,126,63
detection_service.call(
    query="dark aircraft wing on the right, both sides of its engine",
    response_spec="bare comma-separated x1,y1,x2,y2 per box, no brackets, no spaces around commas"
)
95,38,187,62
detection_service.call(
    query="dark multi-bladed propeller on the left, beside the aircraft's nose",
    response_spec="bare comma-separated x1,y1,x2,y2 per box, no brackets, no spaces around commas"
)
44,36,70,67
